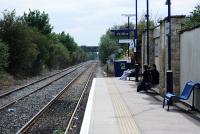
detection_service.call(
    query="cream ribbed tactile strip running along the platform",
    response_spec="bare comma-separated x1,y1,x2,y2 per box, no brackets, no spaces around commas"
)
107,78,140,134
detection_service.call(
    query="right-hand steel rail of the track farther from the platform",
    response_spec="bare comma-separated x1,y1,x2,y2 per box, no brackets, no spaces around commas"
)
0,65,83,111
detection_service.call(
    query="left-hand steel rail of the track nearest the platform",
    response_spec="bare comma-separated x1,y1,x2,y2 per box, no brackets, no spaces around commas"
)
16,64,90,134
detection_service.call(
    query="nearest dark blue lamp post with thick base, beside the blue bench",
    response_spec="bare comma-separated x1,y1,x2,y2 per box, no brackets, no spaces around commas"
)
165,0,173,93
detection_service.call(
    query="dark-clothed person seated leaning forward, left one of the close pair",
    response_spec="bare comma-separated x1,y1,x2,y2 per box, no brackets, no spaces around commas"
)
137,65,151,92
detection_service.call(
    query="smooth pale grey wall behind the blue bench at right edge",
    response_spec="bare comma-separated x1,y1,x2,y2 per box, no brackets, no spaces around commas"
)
180,27,200,110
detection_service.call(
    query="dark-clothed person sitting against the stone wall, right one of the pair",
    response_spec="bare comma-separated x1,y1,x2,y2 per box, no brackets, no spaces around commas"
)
150,64,159,86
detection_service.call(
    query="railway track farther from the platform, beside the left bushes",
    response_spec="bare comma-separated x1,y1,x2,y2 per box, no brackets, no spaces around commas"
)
0,64,83,110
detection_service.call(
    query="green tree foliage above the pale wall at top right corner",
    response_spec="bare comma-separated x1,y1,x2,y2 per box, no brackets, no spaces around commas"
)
185,4,200,28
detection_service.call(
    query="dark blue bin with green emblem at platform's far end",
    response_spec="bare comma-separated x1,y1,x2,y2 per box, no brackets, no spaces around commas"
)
114,60,131,77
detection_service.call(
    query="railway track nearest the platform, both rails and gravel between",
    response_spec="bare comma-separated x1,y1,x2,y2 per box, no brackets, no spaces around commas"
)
17,65,95,134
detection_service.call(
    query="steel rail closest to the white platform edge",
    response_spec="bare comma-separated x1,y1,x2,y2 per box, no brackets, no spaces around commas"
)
64,72,93,134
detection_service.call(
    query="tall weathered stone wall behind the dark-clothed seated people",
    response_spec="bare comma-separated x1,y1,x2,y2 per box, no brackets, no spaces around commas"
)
142,16,185,94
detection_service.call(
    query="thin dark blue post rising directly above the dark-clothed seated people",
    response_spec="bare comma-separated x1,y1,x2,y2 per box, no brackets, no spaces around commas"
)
146,0,149,65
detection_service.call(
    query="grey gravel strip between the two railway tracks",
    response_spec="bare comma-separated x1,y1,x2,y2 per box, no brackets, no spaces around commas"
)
0,63,94,134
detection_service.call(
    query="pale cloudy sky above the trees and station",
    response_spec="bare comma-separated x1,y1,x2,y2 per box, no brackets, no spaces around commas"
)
0,0,200,46
